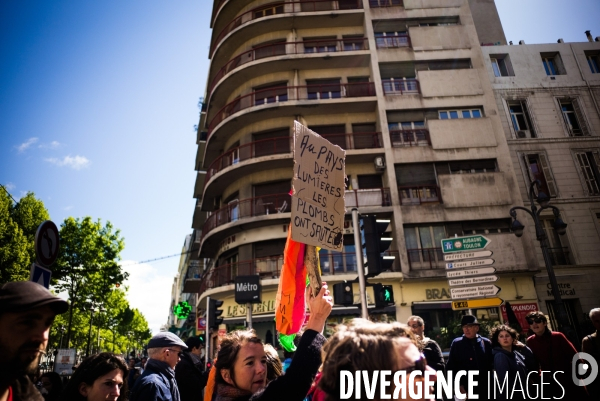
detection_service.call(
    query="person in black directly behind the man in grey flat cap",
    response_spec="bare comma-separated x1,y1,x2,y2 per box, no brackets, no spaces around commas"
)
175,336,209,401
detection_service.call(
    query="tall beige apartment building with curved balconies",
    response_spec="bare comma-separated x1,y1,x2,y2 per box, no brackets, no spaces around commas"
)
184,0,539,348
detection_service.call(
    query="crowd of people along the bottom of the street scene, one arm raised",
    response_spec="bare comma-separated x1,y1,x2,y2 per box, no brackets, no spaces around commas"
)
0,282,600,401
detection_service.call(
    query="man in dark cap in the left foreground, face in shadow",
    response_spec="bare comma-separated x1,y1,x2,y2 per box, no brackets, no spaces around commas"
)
0,281,69,401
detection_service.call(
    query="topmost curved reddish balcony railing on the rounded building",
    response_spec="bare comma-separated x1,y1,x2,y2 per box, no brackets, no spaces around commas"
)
210,0,362,57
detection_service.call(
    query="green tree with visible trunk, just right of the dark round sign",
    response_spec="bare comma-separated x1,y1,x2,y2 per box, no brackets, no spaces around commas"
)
52,217,128,346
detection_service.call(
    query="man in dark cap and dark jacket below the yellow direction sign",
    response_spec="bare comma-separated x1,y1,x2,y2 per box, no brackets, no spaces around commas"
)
446,315,494,400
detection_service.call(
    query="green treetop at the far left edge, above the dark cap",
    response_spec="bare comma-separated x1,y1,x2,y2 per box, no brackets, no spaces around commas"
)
0,187,50,283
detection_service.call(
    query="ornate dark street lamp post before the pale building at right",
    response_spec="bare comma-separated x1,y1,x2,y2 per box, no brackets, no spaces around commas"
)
510,180,573,338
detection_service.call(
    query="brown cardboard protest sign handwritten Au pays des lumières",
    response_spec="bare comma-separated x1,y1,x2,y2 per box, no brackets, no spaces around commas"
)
292,121,346,251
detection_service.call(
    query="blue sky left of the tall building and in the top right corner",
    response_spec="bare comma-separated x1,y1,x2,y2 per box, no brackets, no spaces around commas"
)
0,0,600,331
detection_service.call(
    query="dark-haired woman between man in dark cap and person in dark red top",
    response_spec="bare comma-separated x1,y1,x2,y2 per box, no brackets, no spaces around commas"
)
490,324,539,400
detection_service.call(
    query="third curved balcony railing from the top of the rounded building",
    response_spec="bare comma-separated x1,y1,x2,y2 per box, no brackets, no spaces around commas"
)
208,82,375,137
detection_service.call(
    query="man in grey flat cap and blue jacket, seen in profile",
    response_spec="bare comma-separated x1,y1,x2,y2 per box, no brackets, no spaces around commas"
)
129,331,187,401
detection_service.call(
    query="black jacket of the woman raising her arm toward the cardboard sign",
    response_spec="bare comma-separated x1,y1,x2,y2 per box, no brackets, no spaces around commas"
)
219,330,325,401
